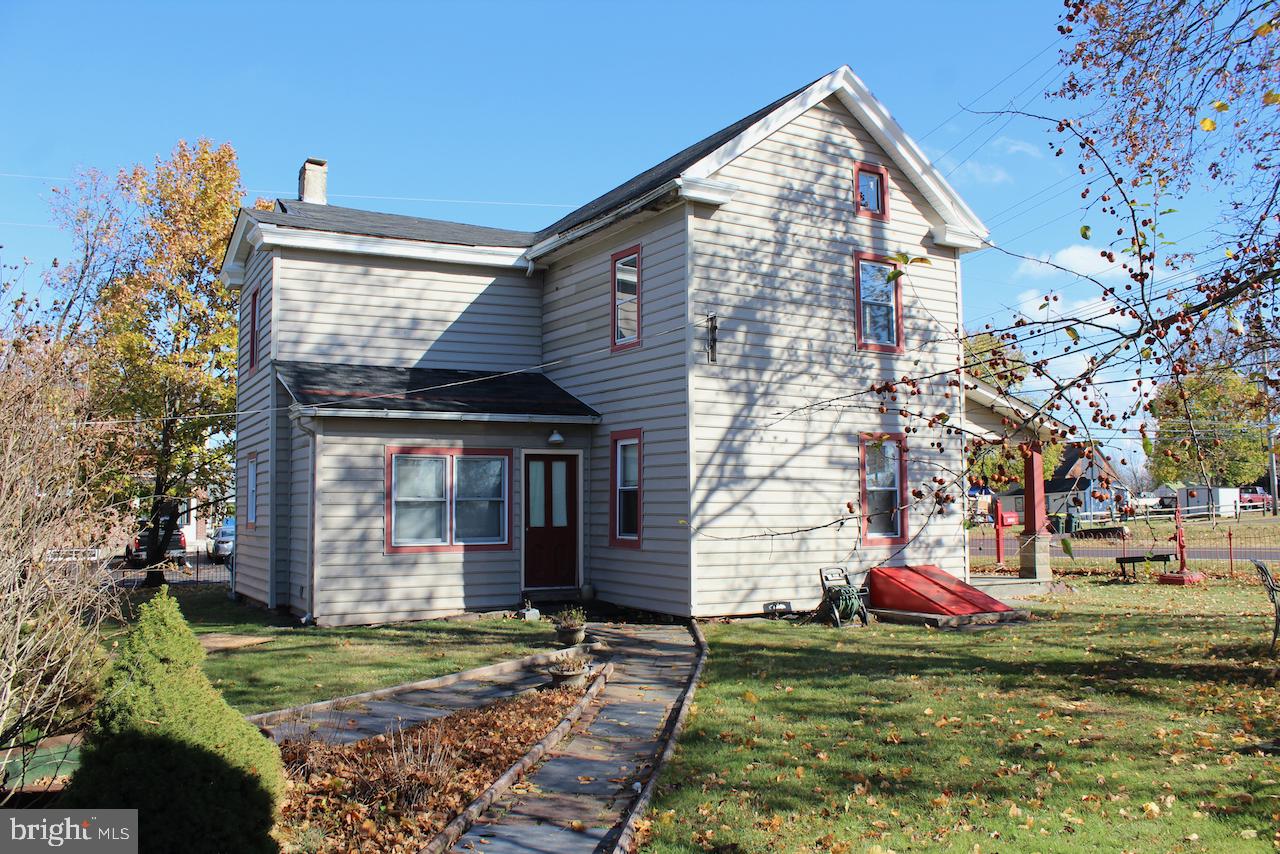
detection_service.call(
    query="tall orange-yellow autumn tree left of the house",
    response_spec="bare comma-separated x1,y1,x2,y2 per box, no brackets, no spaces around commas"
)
60,140,241,583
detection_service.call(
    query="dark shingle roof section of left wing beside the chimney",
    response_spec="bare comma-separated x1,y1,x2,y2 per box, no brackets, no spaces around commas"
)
244,198,536,246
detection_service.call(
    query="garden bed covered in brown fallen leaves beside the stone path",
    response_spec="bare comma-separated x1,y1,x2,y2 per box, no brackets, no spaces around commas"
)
276,689,582,854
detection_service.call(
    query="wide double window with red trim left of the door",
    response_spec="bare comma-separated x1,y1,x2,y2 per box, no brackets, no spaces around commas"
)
385,447,511,553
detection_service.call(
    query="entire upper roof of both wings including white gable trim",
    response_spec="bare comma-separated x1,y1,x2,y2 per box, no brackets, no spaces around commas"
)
223,65,987,280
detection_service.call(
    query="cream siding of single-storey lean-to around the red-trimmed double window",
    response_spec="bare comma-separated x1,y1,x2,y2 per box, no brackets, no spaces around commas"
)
315,419,589,625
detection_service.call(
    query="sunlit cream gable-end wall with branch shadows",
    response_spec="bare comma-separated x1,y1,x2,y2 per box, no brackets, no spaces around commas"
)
690,99,965,615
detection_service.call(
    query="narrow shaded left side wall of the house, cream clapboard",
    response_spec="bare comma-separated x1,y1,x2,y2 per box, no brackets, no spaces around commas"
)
236,251,275,603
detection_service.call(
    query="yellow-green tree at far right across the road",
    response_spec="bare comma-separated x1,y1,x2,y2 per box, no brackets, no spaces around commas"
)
1151,367,1268,487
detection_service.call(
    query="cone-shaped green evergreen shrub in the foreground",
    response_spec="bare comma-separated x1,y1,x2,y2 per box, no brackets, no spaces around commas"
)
63,588,284,851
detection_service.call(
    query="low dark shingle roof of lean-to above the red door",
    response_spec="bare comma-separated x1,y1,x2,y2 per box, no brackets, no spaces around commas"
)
275,361,599,417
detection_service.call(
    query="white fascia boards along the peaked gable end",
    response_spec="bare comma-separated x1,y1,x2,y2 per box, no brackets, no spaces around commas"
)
684,65,988,248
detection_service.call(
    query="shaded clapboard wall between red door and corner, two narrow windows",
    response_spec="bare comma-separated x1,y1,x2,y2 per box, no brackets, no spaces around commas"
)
543,209,690,616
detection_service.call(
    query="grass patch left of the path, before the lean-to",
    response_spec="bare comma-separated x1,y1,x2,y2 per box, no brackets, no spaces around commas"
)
120,588,556,714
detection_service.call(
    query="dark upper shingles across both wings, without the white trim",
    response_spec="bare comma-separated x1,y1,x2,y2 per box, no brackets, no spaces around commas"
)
244,74,813,247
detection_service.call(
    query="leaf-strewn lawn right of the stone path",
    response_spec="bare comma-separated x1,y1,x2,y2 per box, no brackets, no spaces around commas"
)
645,577,1280,853
